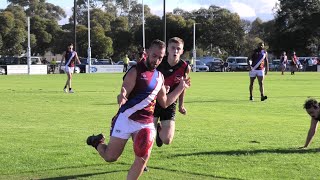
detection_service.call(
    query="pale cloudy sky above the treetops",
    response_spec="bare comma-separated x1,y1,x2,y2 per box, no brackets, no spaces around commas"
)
0,0,278,24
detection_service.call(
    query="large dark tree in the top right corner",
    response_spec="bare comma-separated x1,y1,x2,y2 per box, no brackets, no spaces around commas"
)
271,0,320,55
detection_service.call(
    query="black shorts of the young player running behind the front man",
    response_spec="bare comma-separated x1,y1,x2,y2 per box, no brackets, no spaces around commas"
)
153,103,176,121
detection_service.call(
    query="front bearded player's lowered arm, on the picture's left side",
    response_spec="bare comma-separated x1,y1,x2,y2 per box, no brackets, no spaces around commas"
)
117,67,137,107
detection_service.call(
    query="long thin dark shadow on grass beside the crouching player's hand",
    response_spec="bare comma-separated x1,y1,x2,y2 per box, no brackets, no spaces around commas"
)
172,149,319,157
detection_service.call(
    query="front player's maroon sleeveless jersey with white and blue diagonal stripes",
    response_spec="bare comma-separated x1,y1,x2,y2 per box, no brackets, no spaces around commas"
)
119,60,164,124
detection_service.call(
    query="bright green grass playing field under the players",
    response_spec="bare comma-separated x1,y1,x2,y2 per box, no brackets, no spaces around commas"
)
0,73,320,180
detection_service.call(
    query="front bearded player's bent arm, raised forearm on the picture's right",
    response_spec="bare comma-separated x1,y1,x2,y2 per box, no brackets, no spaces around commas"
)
157,75,190,108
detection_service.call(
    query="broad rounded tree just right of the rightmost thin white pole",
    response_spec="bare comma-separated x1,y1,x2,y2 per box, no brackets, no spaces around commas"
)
192,6,244,55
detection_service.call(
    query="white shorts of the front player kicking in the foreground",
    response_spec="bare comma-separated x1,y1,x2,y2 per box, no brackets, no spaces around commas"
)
110,113,156,139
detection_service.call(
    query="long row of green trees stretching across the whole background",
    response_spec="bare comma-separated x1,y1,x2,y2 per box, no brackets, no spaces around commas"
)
0,0,320,59
